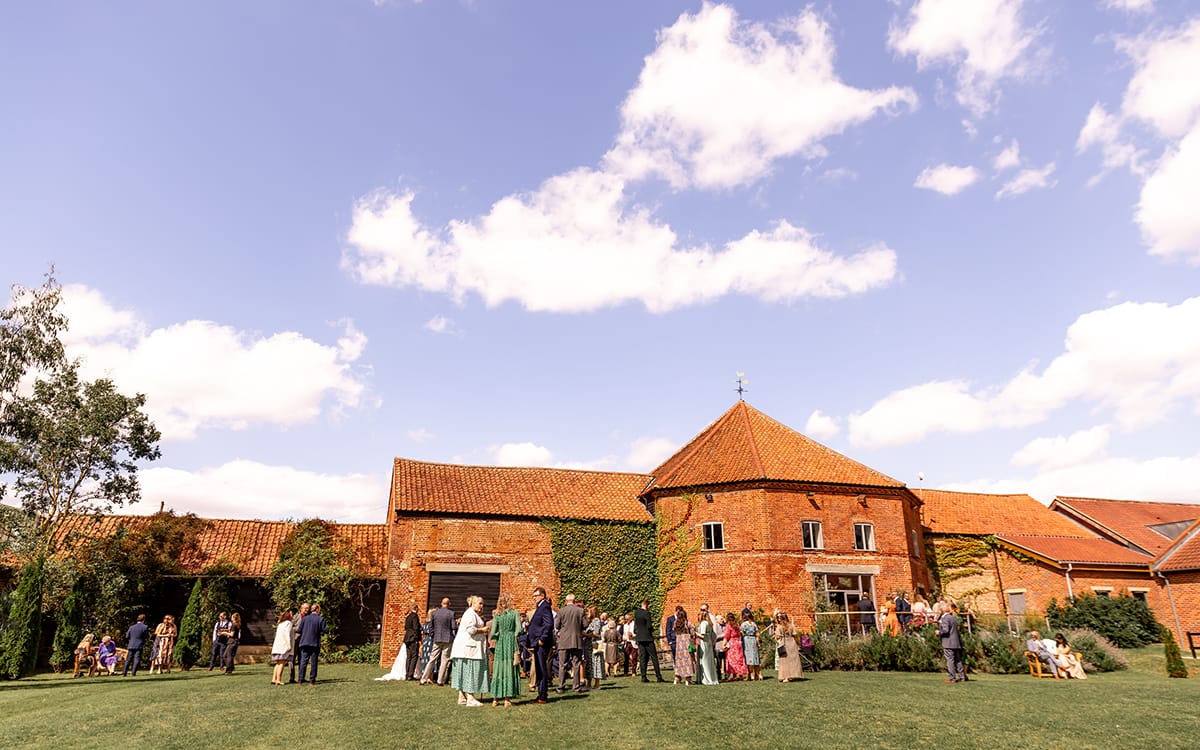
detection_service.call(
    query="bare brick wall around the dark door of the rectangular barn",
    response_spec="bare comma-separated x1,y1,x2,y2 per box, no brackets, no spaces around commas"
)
379,517,558,667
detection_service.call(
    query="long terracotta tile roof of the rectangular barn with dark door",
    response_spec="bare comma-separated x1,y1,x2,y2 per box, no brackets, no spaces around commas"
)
391,458,652,521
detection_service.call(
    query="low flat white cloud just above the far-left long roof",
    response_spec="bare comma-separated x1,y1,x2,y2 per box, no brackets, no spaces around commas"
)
138,461,388,523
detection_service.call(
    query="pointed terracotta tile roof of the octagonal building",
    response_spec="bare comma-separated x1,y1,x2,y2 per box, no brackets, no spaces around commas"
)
650,401,904,490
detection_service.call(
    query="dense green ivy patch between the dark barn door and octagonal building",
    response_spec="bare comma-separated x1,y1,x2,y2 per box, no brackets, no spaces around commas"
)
541,520,662,613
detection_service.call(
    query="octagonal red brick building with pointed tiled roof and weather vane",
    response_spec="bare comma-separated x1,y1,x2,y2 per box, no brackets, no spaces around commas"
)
642,401,928,628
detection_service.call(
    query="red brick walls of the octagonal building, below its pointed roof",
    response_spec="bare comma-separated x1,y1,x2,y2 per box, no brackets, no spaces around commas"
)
656,490,926,628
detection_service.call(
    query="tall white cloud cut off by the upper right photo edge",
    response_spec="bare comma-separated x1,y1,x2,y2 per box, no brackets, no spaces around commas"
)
1075,18,1200,264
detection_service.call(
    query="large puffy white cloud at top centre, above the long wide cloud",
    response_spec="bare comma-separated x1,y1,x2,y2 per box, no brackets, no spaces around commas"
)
605,2,917,187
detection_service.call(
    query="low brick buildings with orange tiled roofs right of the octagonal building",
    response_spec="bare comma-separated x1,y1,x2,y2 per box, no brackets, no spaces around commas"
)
918,490,1200,643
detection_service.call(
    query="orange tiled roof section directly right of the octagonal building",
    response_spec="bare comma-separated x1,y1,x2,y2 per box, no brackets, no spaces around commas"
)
913,490,1096,538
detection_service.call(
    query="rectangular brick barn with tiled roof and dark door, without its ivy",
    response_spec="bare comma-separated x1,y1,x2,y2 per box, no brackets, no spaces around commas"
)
380,458,652,665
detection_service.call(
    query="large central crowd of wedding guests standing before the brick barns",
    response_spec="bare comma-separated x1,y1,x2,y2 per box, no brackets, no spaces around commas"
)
379,588,825,707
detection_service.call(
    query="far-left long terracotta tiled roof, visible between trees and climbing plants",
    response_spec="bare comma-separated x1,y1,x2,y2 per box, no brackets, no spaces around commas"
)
59,516,388,578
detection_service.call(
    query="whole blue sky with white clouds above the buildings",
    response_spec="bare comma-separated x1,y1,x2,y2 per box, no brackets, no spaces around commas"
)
0,0,1200,522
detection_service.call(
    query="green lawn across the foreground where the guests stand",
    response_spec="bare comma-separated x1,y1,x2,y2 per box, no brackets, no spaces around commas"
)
0,647,1200,750
